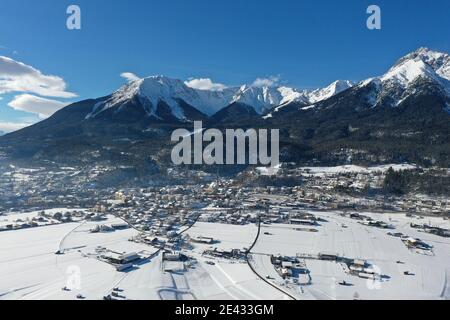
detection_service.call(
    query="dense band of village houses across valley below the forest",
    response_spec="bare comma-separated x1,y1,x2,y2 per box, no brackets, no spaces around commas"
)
0,159,450,223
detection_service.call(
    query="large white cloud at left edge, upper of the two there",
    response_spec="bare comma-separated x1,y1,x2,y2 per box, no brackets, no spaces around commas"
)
0,56,77,98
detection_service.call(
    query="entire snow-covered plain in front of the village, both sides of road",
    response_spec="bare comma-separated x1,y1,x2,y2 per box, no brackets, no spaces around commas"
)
0,212,450,300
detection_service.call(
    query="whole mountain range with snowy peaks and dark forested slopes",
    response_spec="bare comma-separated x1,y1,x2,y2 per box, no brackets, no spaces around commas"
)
0,48,450,166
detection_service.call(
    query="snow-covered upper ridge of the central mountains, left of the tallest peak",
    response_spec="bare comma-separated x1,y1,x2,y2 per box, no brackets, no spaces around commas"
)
87,75,351,121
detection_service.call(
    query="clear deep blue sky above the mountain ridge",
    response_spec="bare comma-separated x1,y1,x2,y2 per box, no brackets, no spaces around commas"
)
0,0,450,131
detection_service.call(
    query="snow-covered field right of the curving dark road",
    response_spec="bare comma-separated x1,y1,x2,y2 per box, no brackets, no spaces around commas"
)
253,212,450,299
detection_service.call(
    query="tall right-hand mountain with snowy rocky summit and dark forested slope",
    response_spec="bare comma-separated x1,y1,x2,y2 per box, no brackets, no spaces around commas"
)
264,48,450,166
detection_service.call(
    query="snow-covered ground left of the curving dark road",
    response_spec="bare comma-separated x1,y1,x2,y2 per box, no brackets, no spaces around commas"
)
0,217,284,300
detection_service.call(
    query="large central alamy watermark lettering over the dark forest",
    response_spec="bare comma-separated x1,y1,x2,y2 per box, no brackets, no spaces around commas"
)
172,121,280,168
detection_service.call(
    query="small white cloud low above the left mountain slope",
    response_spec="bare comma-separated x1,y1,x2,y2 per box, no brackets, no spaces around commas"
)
8,94,68,119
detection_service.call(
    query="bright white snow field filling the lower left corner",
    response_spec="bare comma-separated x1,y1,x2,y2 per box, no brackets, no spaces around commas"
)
0,212,158,300
